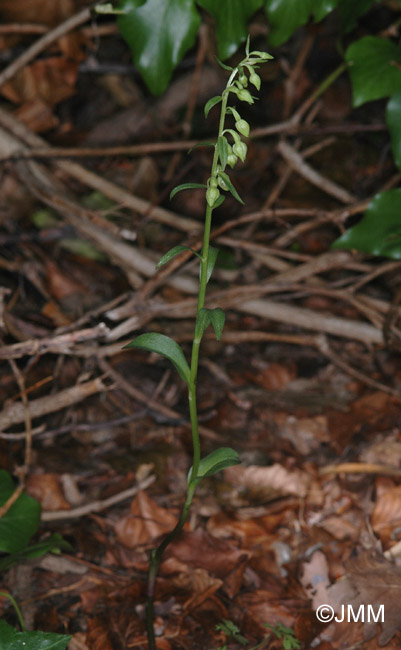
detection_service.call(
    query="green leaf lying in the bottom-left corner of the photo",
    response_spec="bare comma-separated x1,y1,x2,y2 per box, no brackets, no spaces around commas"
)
0,621,72,650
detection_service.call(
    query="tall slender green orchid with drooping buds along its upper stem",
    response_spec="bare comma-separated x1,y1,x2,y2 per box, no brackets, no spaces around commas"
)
125,37,273,650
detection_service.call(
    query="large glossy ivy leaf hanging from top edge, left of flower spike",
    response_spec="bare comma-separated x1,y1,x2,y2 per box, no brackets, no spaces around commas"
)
117,0,200,95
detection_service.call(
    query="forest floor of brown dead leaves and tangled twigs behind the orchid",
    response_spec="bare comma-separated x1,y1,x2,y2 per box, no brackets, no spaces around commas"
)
0,0,401,650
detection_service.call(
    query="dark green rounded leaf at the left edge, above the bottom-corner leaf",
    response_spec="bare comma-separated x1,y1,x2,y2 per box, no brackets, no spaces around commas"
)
0,469,41,553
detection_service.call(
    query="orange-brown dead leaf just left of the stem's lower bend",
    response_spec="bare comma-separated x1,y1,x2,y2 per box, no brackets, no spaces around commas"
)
114,491,177,548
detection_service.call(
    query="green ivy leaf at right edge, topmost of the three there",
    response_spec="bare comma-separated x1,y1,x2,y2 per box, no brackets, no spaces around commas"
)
345,36,401,106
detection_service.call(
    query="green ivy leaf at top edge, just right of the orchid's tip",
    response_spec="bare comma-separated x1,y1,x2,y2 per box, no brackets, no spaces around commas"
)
265,0,340,47
